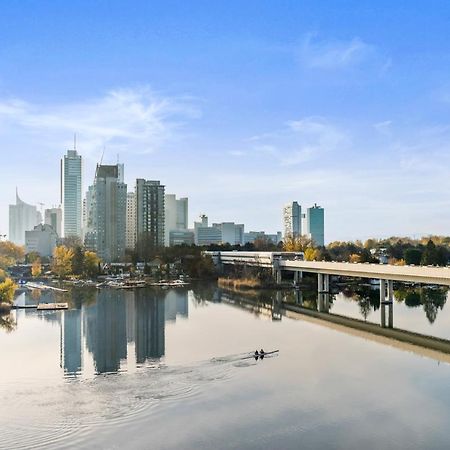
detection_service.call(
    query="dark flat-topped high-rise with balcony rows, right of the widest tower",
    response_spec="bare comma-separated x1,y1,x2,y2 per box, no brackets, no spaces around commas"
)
135,178,165,253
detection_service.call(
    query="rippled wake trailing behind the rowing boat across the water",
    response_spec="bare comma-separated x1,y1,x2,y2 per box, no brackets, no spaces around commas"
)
0,354,264,449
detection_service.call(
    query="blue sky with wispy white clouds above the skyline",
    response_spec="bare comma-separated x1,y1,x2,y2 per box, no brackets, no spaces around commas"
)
0,0,450,242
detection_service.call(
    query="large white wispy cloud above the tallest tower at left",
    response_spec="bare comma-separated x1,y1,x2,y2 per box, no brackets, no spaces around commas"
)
0,87,200,157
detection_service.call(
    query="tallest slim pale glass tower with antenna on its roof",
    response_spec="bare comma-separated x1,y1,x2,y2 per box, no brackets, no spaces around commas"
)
61,149,82,238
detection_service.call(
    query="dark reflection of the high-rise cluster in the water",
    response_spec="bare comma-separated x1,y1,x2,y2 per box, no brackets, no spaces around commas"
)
60,289,188,376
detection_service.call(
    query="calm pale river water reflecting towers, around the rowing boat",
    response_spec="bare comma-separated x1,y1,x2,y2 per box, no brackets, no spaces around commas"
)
0,285,450,449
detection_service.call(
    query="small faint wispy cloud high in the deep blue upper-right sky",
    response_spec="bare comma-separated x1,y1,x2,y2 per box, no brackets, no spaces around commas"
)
299,34,375,70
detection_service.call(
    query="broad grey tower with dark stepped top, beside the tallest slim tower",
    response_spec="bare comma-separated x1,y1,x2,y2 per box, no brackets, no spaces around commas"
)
85,165,127,262
